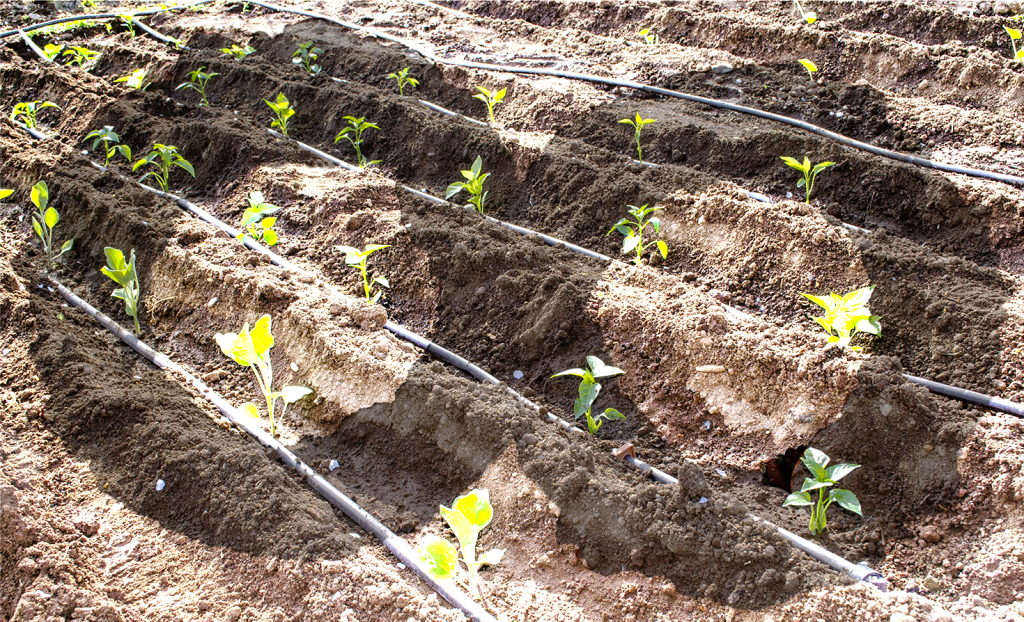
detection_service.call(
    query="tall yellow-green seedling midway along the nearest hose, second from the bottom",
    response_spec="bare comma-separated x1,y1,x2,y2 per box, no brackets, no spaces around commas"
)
213,316,313,434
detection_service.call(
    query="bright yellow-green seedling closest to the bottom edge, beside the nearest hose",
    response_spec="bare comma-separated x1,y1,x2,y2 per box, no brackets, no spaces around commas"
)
417,488,505,607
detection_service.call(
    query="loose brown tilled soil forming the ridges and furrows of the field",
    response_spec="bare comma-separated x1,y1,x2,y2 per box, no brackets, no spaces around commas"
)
0,0,1024,622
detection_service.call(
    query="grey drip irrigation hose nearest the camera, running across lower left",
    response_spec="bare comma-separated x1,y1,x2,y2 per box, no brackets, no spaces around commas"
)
49,277,497,622
